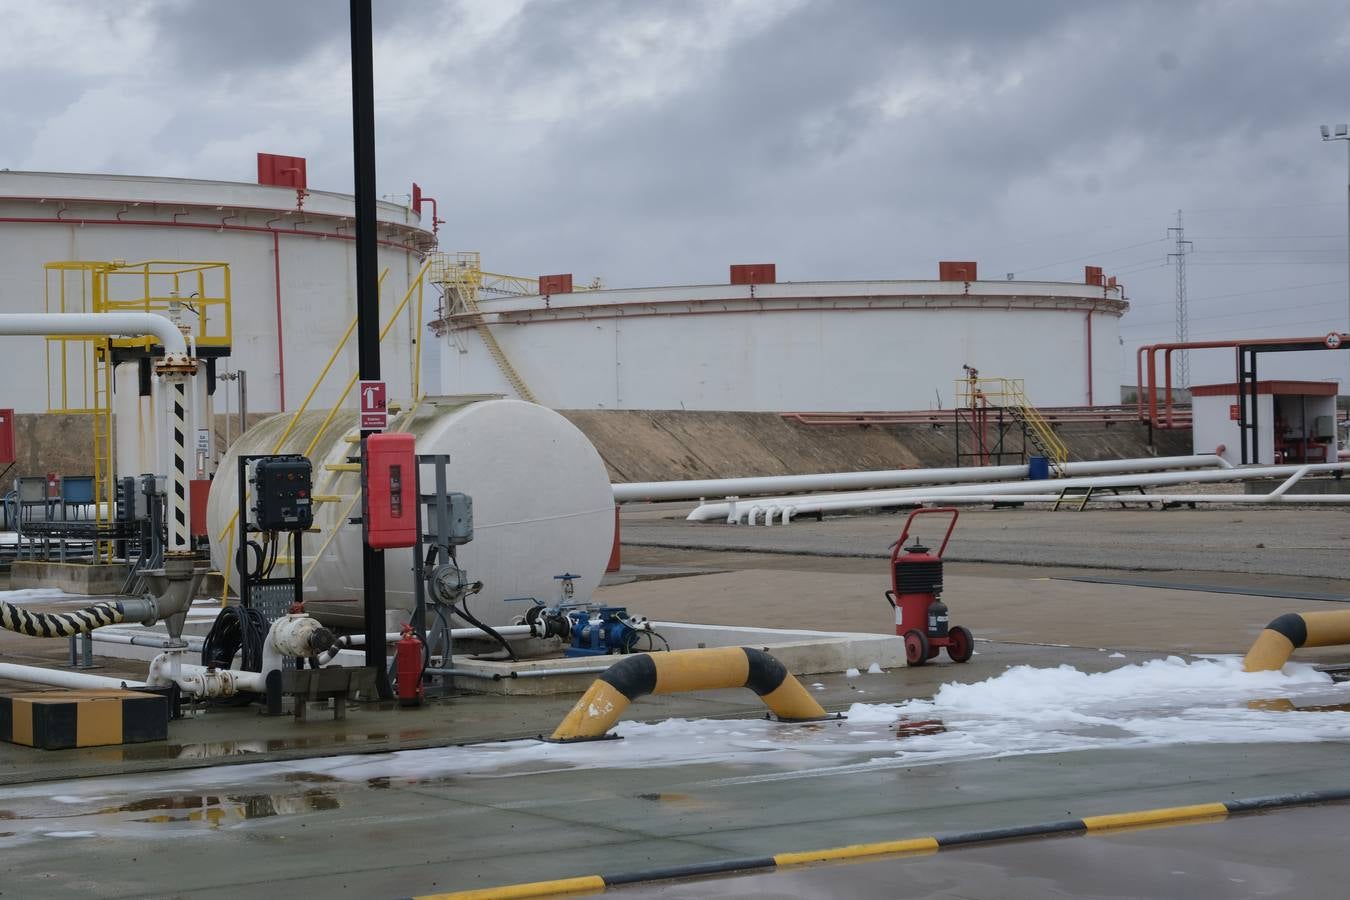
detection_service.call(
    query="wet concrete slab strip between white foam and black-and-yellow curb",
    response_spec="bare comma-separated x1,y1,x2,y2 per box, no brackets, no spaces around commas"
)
0,745,1350,897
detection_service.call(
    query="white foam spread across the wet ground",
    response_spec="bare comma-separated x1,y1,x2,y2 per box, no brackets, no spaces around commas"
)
0,657,1350,847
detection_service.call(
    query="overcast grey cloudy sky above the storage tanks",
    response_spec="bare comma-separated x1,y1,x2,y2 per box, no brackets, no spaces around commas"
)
0,0,1350,382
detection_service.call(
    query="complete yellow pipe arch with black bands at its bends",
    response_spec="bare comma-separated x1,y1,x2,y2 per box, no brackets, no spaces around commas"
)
549,646,825,741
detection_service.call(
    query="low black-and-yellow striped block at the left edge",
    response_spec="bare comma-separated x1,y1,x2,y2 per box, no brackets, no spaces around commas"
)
0,690,169,750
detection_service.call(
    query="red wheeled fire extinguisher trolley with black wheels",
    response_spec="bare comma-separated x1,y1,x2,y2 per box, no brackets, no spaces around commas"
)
886,506,975,665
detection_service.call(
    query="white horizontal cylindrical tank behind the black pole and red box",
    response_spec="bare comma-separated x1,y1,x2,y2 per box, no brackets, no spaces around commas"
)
207,397,614,629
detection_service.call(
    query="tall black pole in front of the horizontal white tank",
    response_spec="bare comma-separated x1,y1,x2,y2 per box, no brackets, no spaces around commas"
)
351,0,393,699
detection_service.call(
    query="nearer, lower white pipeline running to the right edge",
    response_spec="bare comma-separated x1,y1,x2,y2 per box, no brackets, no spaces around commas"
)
707,463,1346,525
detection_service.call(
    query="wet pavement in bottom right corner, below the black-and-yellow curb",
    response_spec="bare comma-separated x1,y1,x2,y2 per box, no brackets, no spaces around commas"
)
606,806,1347,900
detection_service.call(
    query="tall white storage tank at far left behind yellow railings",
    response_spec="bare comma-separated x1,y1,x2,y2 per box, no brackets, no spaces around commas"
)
0,170,435,415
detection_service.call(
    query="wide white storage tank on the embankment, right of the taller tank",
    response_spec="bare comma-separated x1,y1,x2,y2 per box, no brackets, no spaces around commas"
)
433,281,1129,413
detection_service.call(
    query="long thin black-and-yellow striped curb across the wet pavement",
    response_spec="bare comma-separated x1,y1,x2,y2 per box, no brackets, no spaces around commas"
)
405,788,1350,900
